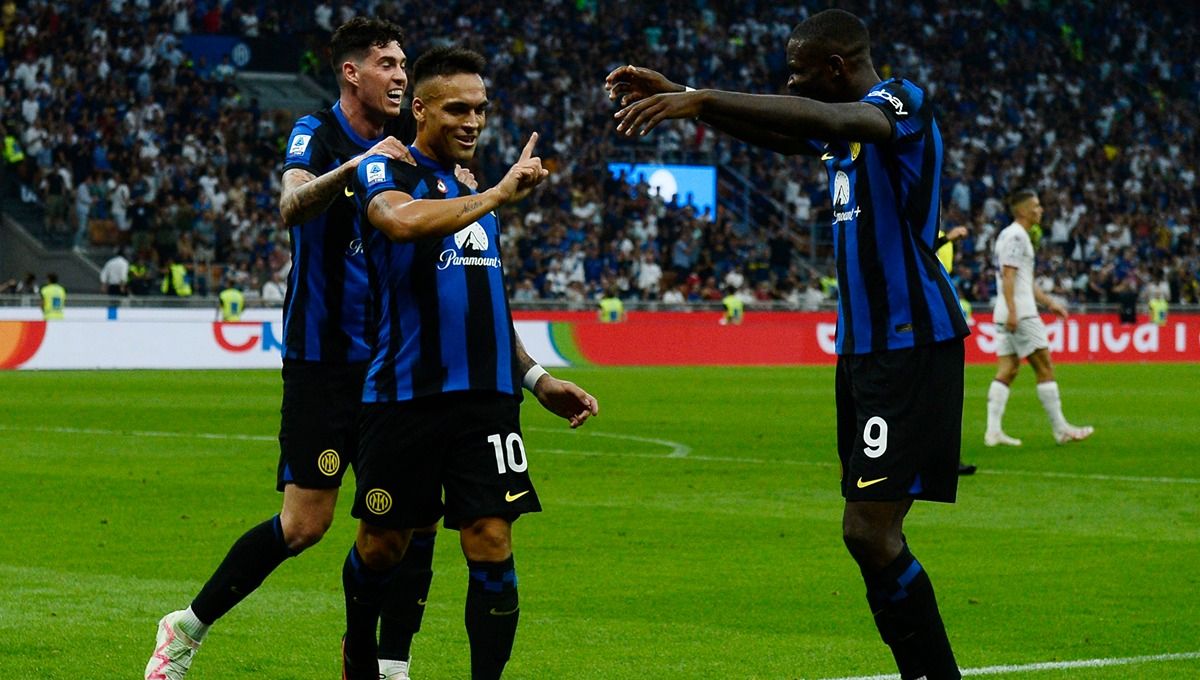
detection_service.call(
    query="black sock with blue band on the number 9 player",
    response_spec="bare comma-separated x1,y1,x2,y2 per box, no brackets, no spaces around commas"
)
864,544,962,680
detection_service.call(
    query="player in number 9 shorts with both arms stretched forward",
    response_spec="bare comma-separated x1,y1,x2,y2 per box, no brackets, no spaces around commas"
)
606,10,970,680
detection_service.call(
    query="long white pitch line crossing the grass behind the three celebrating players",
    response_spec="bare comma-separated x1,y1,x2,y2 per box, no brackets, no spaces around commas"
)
0,425,1200,485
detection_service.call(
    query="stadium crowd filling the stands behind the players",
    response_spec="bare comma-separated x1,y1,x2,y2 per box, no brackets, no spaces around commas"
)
0,0,1200,307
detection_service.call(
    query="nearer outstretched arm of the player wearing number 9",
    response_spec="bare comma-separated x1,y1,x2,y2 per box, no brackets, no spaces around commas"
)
613,90,892,152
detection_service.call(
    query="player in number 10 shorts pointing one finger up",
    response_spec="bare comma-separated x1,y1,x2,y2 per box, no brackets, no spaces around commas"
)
342,47,598,680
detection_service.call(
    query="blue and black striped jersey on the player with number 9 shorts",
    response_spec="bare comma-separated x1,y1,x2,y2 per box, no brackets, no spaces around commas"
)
810,78,971,354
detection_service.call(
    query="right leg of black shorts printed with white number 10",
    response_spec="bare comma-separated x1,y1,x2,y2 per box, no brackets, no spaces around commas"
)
442,392,541,528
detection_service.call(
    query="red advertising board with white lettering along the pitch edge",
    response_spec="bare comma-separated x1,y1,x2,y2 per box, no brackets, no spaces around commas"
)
514,312,1200,366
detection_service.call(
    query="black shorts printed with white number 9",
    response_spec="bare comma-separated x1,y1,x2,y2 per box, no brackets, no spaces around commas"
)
836,339,964,503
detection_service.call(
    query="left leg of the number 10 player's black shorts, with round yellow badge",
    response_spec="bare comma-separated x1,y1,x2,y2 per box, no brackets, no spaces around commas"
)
350,397,458,529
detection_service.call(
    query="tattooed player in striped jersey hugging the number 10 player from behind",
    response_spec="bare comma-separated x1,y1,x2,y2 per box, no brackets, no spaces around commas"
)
145,18,458,680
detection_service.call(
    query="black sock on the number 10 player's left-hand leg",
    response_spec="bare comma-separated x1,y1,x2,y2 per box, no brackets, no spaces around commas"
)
342,546,395,680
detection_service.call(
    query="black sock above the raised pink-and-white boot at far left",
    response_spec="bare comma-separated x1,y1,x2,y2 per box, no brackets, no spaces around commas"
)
192,514,299,625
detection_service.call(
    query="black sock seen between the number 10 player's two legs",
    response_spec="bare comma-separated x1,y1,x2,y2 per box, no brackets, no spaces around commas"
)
379,534,438,661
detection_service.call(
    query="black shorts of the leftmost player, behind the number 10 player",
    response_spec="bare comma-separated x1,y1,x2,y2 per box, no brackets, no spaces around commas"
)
275,360,367,491
